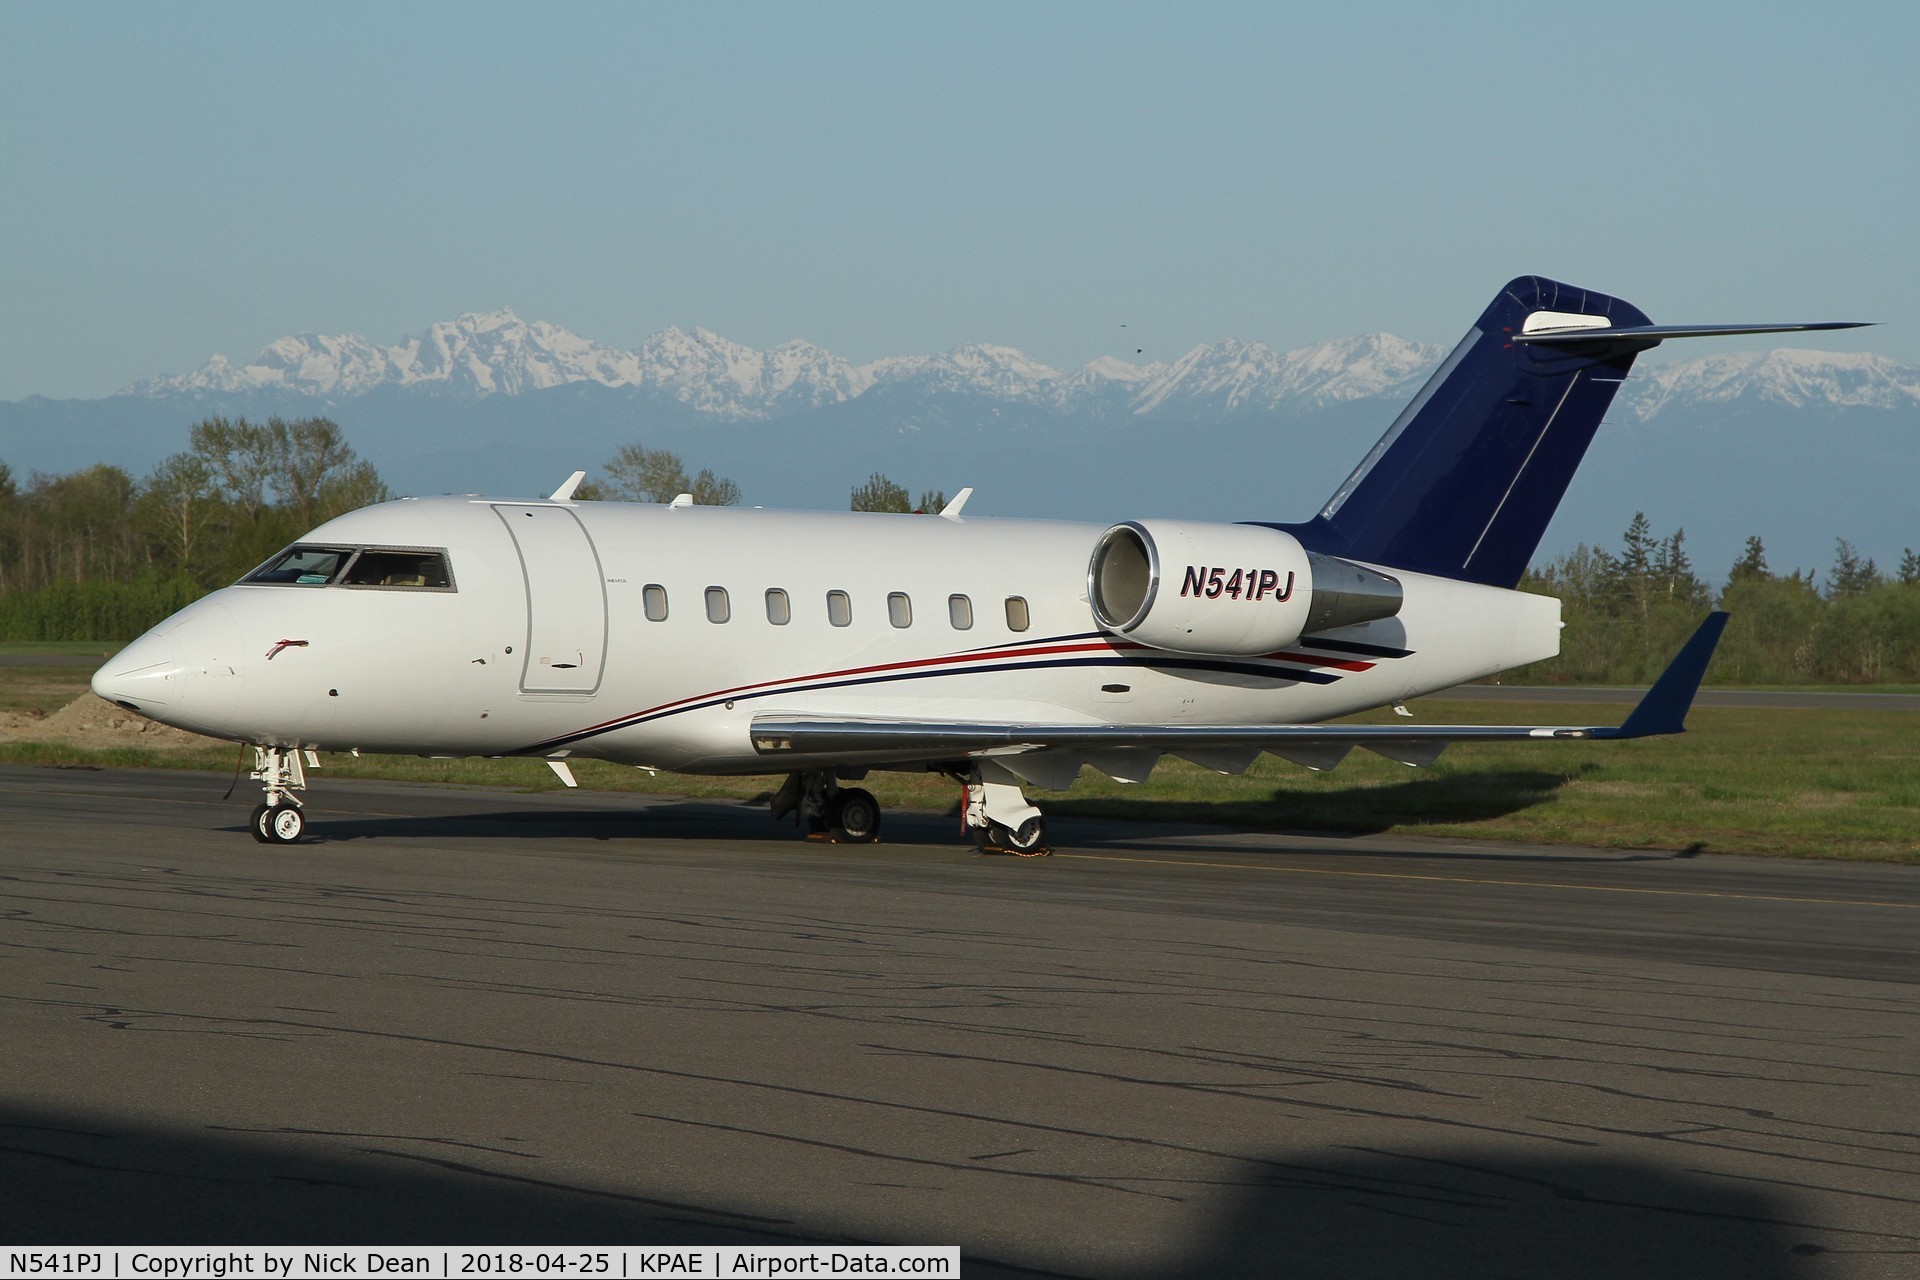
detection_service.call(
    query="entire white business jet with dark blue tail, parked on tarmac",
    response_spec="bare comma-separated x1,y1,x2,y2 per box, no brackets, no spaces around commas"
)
92,276,1851,854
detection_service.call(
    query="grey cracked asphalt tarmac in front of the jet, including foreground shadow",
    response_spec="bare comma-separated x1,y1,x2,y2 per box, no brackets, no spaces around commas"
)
0,766,1920,1280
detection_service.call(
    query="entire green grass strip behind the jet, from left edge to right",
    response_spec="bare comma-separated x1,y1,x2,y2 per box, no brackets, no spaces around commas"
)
0,699,1920,862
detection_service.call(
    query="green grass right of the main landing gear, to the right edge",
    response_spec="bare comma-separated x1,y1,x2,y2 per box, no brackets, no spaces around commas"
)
1050,700,1920,862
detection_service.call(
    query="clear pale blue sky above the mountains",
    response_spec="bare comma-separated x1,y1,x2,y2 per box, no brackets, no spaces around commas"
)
0,0,1920,399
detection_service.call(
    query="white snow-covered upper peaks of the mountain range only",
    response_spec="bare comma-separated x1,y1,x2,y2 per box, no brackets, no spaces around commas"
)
123,307,1920,422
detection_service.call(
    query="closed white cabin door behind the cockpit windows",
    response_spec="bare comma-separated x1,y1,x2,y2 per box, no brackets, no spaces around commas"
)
493,503,607,695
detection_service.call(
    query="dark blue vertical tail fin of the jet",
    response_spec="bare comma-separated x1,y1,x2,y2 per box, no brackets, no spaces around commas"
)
1283,276,1659,587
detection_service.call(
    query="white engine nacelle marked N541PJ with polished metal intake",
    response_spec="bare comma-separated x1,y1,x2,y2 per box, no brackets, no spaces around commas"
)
1087,520,1402,656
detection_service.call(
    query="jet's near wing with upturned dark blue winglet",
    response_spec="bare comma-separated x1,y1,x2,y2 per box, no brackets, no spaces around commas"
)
753,612,1726,771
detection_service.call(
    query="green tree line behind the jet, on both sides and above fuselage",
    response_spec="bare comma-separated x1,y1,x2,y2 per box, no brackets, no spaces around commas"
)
0,418,1920,683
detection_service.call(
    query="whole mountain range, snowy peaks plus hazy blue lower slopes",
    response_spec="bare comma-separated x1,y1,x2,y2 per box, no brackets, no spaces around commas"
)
0,309,1920,566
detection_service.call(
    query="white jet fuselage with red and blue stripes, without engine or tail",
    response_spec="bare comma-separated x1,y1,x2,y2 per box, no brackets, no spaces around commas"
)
93,497,1559,773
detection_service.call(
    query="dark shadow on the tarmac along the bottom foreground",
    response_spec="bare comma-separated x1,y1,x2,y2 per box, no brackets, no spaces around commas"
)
0,1103,1847,1280
